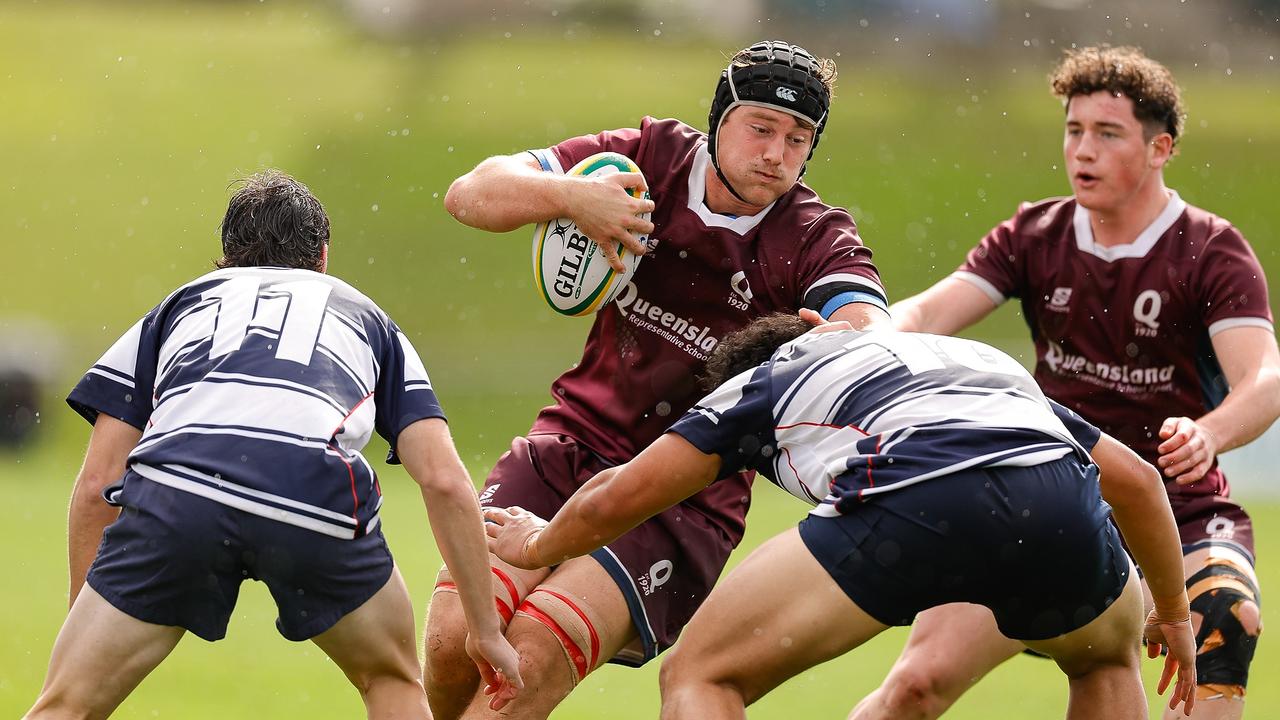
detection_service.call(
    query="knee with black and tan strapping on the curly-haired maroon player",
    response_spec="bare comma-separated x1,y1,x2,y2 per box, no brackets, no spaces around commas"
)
1187,562,1262,700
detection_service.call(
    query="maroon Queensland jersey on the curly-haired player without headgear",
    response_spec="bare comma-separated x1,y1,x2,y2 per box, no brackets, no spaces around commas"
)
952,192,1272,496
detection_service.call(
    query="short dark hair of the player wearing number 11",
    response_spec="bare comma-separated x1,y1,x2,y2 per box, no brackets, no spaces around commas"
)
215,169,329,272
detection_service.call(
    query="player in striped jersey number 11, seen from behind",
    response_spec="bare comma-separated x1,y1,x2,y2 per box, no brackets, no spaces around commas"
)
27,170,521,717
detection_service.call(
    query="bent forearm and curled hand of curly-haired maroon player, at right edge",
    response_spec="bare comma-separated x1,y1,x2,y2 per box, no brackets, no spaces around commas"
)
1157,327,1280,484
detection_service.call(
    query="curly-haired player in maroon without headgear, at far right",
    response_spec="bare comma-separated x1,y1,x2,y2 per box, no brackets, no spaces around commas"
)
851,47,1280,720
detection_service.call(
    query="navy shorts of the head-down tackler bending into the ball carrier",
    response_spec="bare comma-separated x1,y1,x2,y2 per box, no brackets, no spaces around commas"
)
800,456,1130,641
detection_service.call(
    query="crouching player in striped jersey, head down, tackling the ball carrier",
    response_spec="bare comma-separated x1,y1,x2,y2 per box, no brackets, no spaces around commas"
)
485,315,1196,720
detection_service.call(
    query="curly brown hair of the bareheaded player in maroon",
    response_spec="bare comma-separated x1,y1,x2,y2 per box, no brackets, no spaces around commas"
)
1050,45,1187,145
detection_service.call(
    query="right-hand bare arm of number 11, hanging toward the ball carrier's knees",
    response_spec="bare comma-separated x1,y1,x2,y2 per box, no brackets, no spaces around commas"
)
396,418,524,707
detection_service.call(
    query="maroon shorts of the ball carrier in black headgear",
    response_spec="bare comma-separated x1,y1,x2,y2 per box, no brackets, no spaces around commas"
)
480,434,741,666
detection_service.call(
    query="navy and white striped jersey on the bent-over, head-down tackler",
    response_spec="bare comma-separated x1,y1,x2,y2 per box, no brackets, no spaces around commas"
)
671,331,1100,516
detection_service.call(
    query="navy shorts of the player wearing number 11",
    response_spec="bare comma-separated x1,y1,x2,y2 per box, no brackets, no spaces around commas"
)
88,471,393,641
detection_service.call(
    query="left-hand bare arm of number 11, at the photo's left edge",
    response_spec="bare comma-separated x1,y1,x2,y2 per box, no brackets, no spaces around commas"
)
67,414,142,605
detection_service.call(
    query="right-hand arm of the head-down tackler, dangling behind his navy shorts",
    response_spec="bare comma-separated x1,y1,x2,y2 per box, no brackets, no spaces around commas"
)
1092,434,1196,715
